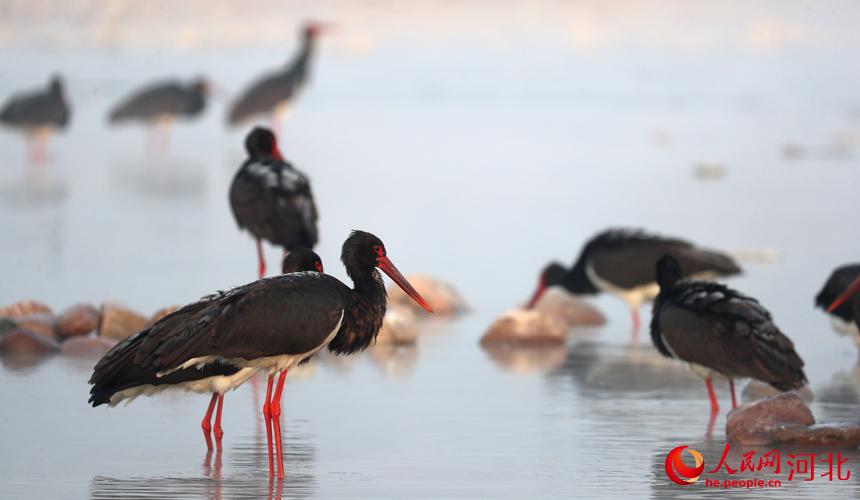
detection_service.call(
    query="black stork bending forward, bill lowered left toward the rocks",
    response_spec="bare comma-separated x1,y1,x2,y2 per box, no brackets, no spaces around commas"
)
528,229,741,335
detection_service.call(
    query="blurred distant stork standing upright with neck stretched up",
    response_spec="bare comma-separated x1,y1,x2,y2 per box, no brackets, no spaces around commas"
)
228,22,331,130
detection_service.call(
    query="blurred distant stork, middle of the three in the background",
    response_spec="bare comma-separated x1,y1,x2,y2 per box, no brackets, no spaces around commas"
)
108,78,211,147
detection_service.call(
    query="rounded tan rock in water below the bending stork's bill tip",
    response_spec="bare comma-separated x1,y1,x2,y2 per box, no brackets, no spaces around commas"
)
481,309,567,346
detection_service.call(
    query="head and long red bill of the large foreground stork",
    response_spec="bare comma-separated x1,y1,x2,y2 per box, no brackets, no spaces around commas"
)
340,230,433,313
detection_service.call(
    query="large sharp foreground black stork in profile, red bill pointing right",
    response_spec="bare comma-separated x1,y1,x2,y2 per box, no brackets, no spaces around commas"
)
90,231,433,478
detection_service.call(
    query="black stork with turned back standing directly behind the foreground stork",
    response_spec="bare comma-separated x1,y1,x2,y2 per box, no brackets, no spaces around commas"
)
230,127,319,278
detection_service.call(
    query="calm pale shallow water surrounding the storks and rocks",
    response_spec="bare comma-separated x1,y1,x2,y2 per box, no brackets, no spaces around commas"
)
0,2,860,498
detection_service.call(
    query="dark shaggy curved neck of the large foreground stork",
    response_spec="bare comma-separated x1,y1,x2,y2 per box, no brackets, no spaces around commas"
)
329,269,388,354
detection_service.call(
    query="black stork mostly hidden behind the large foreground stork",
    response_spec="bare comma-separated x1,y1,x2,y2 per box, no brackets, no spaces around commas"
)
89,249,323,450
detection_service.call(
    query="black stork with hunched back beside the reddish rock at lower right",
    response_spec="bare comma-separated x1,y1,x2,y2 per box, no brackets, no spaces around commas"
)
651,255,806,416
